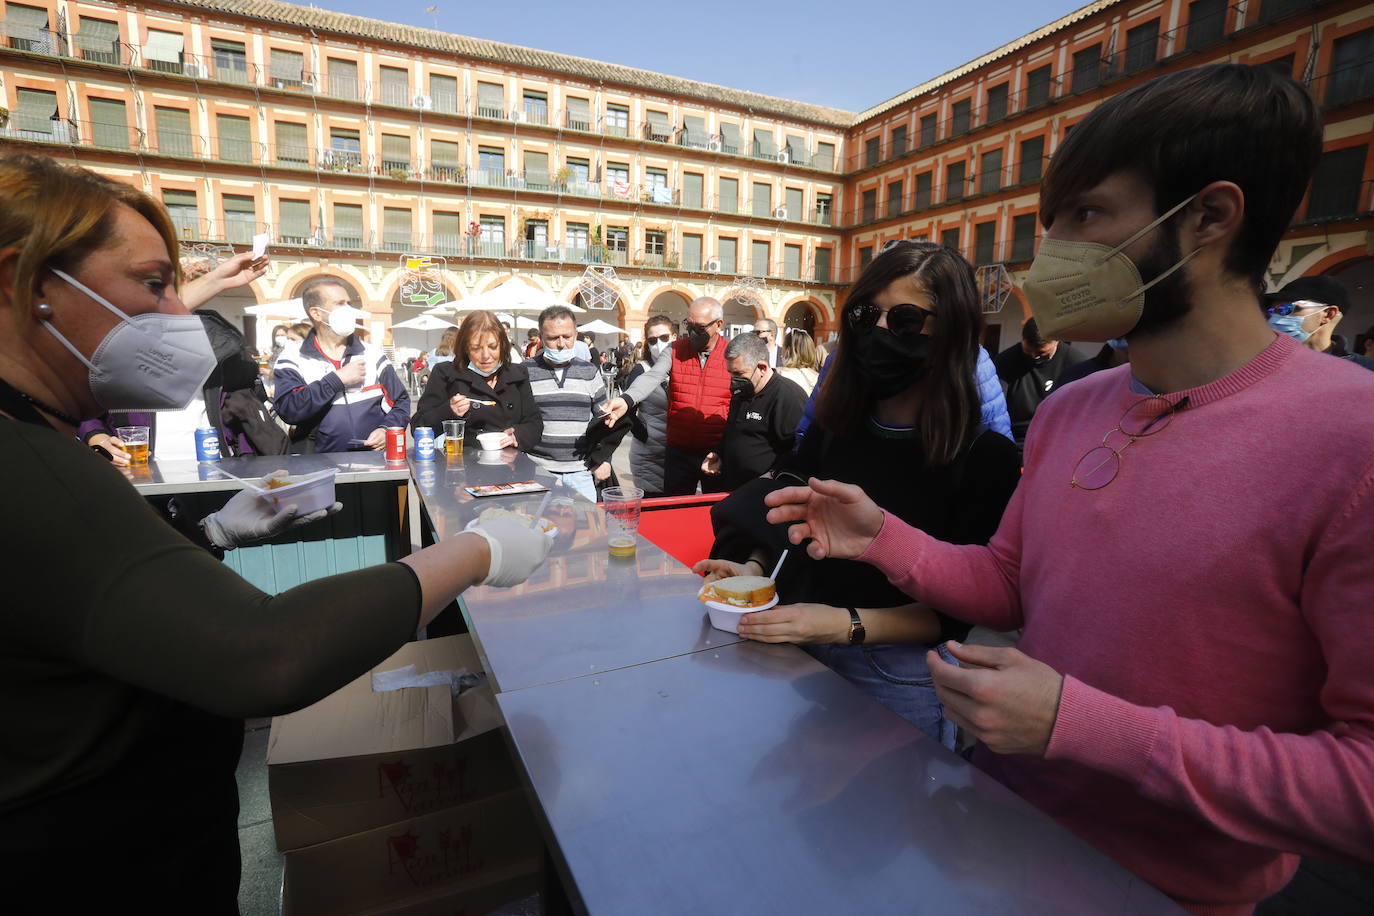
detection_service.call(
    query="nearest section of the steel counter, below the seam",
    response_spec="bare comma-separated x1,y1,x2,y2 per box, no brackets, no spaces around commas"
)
496,643,1182,916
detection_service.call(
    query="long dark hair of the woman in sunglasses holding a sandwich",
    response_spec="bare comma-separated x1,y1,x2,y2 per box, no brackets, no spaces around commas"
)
816,242,982,467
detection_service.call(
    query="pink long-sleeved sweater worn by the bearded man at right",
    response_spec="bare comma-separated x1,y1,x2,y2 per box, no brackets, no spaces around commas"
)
861,335,1374,916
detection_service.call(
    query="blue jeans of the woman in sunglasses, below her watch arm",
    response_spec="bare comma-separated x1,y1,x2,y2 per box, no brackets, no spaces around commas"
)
801,643,958,750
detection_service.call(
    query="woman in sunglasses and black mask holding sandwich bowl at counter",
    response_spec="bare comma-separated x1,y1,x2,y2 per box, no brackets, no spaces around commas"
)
695,242,1020,747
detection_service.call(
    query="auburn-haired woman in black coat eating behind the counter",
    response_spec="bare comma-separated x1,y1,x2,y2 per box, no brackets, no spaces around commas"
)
411,312,544,450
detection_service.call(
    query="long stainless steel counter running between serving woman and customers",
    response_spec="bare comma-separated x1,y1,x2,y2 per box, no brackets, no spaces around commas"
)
414,453,1182,916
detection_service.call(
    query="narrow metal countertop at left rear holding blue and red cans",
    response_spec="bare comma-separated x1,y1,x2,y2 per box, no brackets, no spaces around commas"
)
122,452,411,496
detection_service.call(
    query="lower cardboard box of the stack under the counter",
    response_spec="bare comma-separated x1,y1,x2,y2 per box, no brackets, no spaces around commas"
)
282,790,543,916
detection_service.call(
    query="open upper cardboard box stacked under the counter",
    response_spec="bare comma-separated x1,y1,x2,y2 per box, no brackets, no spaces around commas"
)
267,636,519,851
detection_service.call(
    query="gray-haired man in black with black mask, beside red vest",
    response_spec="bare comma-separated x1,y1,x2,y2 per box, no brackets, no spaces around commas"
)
701,334,807,490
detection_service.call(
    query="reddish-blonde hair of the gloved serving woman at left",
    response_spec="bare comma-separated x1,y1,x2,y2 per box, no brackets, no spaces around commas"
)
0,154,181,330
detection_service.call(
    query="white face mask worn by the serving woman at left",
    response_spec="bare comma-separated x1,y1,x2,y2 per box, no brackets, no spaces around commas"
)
43,269,216,411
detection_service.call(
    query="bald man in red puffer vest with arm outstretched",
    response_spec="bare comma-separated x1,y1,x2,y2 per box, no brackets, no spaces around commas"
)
606,297,730,496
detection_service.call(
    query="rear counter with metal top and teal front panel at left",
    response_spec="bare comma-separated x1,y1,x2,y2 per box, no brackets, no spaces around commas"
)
133,452,419,595
